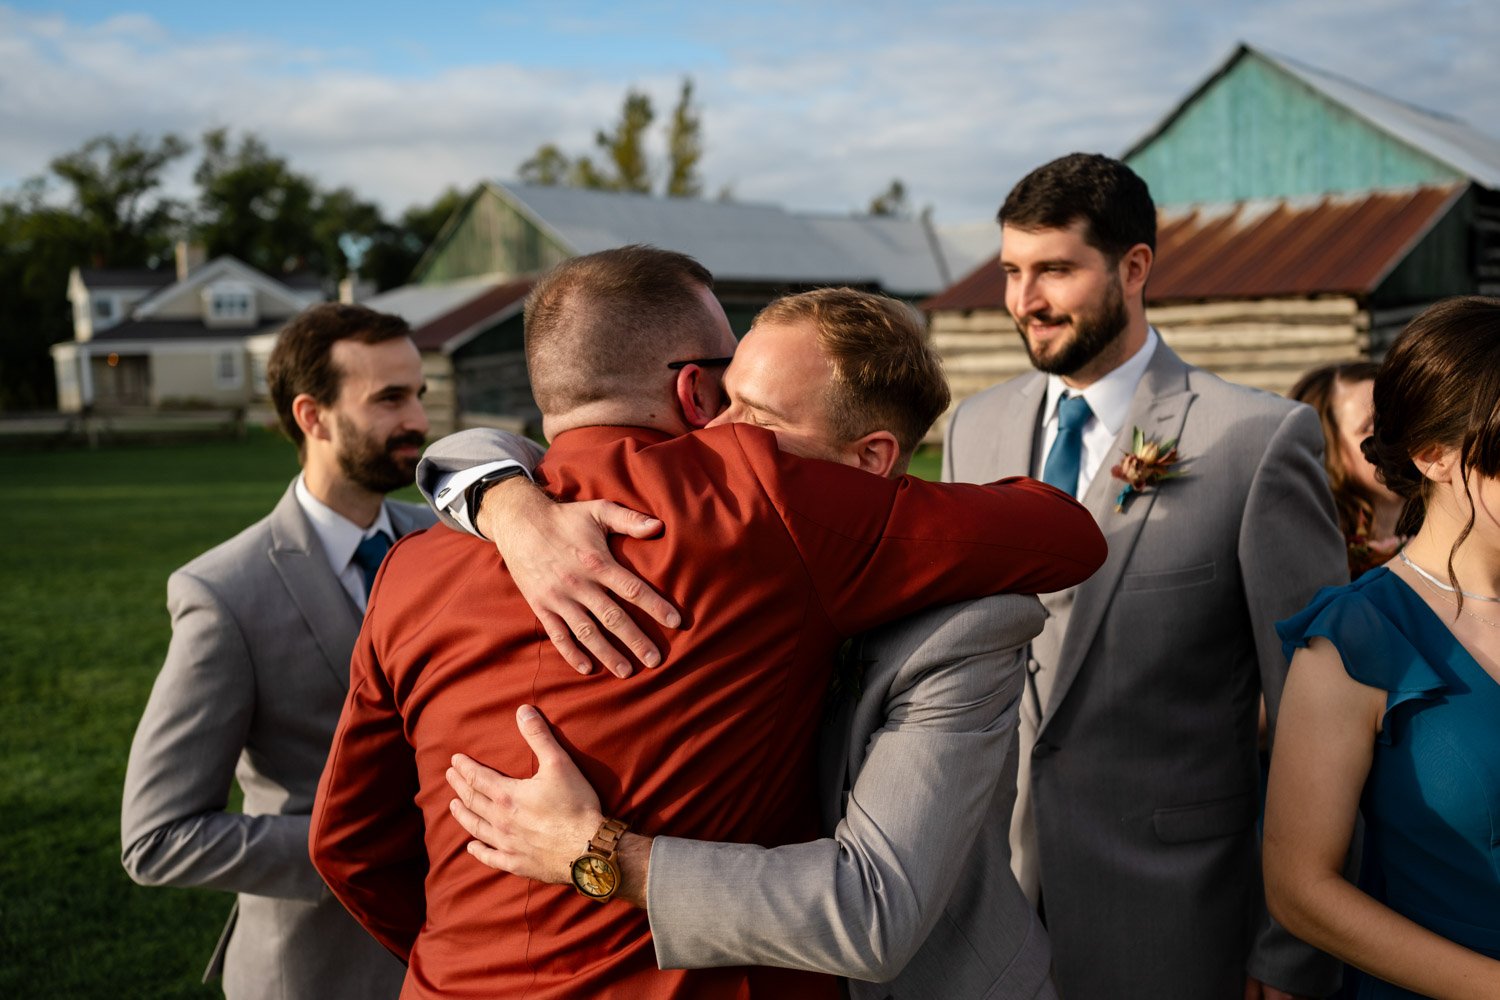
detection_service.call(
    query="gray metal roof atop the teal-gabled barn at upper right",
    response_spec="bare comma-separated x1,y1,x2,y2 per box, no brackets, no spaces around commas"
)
1121,43,1500,190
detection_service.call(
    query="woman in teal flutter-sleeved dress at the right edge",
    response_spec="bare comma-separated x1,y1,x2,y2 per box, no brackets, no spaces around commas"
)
1265,297,1500,1000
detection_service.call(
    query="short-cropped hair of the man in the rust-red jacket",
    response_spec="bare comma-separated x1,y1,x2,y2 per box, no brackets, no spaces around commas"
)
527,244,716,414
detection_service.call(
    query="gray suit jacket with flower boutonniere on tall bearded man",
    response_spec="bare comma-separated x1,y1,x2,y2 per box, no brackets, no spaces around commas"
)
944,343,1346,1000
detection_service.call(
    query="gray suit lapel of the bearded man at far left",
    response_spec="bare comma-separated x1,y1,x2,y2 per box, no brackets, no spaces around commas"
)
269,487,360,688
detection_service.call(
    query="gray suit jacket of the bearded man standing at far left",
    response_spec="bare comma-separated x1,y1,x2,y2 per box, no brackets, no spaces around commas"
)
120,479,432,1000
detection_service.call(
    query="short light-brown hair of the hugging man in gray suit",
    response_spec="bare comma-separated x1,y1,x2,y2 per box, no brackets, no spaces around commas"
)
756,288,951,465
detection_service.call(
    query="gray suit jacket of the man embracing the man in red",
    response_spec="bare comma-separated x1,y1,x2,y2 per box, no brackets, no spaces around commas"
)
648,595,1055,1000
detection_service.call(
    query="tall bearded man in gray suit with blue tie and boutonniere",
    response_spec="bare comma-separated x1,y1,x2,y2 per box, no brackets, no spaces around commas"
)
944,153,1346,1000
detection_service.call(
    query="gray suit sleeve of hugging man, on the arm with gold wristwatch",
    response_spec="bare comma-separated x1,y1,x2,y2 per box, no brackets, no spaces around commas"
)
647,603,1044,982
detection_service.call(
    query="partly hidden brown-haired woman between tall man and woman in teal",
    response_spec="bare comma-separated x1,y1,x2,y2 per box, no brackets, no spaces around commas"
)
1287,361,1401,580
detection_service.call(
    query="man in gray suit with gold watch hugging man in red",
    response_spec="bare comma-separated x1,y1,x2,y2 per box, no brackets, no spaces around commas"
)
419,283,1080,999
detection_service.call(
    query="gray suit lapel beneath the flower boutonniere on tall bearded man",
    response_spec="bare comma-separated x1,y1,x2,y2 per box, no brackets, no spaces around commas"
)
1037,342,1197,735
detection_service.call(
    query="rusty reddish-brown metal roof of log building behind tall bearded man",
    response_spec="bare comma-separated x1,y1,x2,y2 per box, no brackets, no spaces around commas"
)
921,184,1464,312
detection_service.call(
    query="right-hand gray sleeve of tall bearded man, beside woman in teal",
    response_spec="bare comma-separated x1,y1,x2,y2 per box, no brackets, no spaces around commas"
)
1239,406,1349,997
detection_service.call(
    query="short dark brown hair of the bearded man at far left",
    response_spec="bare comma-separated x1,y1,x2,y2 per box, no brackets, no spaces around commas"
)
266,301,411,454
